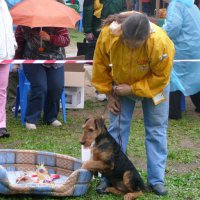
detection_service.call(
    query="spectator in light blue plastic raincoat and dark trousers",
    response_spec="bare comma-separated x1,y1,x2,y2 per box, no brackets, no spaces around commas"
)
163,0,200,119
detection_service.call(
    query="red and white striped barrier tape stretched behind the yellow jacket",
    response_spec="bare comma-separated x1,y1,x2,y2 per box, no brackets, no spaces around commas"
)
0,59,200,64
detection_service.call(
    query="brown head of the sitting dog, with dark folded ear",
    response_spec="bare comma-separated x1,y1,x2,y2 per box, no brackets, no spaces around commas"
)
80,117,106,147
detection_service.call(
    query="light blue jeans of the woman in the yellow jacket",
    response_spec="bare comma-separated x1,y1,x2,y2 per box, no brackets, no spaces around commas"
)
108,85,169,185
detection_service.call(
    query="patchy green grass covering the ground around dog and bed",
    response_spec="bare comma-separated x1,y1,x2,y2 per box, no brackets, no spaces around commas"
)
0,101,200,200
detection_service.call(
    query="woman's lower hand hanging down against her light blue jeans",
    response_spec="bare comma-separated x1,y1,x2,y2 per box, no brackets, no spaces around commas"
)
107,94,120,115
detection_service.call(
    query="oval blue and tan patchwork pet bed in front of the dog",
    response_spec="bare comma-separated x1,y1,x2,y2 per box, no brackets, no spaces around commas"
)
0,149,92,196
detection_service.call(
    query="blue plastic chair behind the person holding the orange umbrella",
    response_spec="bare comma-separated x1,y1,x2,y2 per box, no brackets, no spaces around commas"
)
14,69,66,125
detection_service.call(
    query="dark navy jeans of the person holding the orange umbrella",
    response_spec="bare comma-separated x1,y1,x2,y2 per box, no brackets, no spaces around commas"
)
23,64,64,124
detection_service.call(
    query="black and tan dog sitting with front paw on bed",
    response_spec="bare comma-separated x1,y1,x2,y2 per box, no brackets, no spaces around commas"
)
80,117,145,200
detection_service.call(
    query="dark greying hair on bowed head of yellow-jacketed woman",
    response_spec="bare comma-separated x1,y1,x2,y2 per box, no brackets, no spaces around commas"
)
122,13,150,41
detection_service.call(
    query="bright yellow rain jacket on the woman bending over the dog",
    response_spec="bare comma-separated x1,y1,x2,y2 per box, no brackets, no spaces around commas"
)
92,23,174,98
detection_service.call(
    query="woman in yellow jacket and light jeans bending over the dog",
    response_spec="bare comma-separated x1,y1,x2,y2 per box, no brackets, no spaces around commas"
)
92,12,174,195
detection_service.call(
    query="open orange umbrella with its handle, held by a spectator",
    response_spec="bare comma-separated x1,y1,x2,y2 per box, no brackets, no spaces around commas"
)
10,0,81,52
